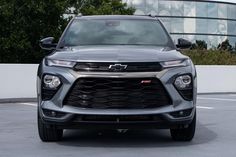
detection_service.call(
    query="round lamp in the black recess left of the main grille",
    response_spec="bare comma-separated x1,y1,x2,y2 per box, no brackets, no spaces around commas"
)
43,75,61,89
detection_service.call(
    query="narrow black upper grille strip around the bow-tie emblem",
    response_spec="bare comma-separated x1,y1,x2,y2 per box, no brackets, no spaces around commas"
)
74,62,162,72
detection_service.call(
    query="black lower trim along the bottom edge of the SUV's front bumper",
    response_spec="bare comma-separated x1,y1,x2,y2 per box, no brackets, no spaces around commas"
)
43,114,194,129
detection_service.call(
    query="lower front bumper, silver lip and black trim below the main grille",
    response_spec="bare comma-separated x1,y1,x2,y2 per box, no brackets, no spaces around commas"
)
40,108,195,129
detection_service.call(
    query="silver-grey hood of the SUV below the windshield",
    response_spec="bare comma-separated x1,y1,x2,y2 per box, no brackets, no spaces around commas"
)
48,46,187,62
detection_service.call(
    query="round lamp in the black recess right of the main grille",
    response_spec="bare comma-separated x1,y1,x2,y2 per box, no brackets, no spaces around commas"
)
174,75,192,90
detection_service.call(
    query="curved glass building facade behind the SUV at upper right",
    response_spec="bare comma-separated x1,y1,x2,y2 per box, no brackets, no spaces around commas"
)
124,0,236,48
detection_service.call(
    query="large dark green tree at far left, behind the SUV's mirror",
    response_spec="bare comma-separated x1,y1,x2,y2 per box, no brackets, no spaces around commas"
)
0,0,67,63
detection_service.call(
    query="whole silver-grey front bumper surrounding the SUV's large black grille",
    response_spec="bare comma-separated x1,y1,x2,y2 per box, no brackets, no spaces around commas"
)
38,62,197,128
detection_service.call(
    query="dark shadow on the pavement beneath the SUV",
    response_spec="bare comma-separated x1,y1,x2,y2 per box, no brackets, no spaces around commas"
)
58,122,217,148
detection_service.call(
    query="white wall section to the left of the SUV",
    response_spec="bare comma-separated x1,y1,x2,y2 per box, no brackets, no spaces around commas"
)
0,64,38,99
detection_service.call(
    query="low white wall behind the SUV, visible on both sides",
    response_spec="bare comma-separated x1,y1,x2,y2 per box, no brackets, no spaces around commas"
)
0,64,236,99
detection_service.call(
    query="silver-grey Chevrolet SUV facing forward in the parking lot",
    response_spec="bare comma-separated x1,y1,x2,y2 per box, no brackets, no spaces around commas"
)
37,16,197,142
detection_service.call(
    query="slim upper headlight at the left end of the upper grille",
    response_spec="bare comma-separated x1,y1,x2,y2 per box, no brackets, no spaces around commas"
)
46,59,76,68
